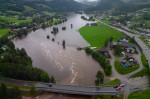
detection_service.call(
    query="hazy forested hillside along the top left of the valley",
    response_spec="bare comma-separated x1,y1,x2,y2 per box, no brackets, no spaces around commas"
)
0,0,83,12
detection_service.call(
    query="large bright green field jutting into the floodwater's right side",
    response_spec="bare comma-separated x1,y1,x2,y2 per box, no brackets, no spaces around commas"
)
79,24,125,47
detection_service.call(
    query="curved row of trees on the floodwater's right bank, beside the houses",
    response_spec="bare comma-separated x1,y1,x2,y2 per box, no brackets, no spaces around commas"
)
85,48,112,76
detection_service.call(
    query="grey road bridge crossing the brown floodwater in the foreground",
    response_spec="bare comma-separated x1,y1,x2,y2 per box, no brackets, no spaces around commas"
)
35,83,124,96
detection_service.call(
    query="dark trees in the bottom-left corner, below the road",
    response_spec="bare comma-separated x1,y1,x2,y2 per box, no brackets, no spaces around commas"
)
0,83,21,99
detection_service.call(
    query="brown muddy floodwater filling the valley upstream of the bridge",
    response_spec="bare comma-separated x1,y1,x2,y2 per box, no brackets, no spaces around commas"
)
13,13,108,99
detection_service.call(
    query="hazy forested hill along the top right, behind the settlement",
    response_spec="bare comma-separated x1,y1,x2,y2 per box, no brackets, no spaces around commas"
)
85,0,150,15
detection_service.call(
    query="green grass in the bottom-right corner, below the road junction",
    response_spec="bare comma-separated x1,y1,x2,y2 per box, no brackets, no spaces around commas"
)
128,89,150,99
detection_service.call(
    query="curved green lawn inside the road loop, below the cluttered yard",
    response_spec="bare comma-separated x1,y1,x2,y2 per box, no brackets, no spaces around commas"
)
114,61,140,75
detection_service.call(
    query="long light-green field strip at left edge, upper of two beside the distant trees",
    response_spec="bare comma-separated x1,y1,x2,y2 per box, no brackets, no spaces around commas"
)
0,17,32,23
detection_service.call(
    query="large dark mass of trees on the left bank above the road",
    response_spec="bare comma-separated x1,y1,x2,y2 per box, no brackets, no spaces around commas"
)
0,37,49,82
